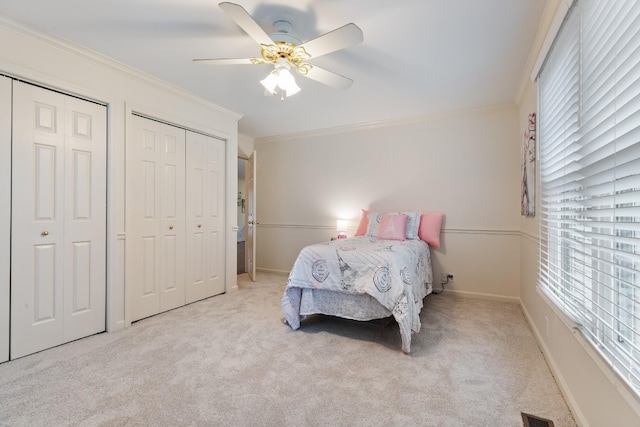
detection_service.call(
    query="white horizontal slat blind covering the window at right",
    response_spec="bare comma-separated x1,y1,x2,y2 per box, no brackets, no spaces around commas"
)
538,0,640,396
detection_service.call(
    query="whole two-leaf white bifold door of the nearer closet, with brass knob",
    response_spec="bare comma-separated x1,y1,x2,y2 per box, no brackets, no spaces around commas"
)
11,82,106,358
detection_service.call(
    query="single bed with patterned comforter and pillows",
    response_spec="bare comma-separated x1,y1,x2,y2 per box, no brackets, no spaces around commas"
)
281,211,441,353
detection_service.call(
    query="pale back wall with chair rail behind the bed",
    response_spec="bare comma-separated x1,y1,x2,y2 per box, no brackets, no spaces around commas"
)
255,106,520,299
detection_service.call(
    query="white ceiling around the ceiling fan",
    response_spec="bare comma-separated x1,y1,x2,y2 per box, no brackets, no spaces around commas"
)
0,0,547,138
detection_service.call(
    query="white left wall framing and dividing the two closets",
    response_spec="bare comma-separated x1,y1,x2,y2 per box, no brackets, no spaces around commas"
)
0,18,240,330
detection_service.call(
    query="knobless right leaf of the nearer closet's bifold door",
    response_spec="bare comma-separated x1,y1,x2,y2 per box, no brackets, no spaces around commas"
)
64,97,107,342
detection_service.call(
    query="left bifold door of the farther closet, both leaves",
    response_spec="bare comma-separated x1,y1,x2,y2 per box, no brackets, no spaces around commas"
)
127,116,185,320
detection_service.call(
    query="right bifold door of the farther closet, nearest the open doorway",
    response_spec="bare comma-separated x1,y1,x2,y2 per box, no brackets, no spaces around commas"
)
186,131,225,303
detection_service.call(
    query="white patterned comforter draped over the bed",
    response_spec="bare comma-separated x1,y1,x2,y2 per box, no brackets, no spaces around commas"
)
282,237,432,353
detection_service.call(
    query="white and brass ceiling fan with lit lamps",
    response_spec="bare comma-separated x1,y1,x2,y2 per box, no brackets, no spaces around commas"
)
193,2,363,100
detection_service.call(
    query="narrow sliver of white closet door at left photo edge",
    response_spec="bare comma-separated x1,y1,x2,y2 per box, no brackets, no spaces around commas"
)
0,76,11,362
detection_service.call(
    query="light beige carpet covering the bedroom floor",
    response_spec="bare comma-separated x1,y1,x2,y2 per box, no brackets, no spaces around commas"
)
0,273,575,427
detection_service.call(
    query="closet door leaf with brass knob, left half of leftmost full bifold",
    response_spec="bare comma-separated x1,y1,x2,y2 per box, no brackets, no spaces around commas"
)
11,82,65,358
